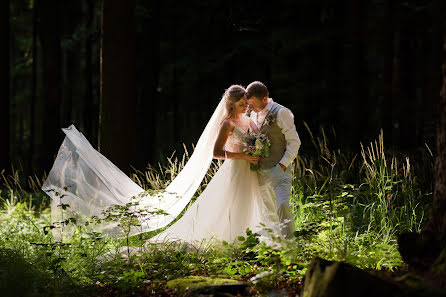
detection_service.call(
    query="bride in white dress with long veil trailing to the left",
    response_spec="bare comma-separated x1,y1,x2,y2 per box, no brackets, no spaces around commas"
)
42,85,279,242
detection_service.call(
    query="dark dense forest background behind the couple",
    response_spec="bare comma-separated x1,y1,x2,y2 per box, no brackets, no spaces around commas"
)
0,0,443,175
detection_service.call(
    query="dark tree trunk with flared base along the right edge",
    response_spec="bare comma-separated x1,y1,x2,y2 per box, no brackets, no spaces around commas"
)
398,0,446,268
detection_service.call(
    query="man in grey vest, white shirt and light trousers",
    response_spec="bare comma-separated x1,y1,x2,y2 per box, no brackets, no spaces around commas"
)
245,81,301,239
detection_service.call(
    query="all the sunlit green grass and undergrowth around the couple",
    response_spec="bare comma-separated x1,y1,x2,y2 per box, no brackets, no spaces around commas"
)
0,131,433,296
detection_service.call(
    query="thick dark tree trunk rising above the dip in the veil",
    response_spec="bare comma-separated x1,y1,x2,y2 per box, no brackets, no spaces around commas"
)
99,0,136,171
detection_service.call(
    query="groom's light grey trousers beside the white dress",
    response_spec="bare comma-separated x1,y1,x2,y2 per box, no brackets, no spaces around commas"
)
258,164,295,239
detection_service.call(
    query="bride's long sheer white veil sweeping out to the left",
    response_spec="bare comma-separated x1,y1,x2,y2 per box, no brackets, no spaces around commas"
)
42,99,225,235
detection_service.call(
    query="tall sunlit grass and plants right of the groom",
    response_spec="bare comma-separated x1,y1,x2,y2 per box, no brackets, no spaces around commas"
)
291,127,433,270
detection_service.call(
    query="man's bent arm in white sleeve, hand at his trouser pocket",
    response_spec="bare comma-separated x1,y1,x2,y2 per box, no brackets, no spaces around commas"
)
277,108,301,169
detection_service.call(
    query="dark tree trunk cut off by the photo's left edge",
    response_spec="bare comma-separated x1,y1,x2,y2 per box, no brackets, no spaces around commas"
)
0,0,11,172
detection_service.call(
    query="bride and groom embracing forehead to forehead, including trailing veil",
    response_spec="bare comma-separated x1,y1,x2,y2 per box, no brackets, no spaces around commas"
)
42,81,301,242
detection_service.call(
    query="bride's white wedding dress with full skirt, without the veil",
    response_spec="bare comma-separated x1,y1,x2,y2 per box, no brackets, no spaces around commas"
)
152,126,279,242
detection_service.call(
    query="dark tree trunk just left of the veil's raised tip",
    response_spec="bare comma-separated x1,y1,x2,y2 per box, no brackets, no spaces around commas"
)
38,0,63,171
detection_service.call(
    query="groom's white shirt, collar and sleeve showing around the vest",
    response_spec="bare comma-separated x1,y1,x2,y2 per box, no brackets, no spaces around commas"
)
251,98,301,167
